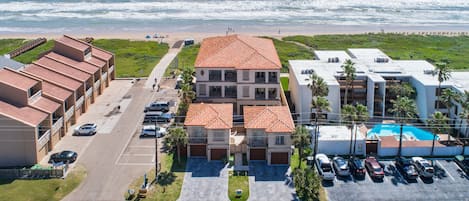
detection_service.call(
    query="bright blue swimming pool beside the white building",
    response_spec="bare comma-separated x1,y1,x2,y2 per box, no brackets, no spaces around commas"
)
366,124,438,140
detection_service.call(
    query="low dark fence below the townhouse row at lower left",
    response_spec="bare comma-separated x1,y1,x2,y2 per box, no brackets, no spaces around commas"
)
0,167,68,179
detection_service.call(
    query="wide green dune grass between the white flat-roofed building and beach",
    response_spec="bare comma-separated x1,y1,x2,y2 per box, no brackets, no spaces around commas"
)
283,34,469,69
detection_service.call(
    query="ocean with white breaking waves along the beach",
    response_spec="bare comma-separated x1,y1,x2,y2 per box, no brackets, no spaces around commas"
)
0,0,469,34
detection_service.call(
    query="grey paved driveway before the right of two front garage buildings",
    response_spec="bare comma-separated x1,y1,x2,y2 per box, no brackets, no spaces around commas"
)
249,161,298,201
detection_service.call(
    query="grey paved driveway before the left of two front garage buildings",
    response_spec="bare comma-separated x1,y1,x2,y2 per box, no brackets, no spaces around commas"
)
178,158,229,201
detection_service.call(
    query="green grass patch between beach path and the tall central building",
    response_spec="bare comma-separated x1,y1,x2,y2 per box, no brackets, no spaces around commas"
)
164,44,200,76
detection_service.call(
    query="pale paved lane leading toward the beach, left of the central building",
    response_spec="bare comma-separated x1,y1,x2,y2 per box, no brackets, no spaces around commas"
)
63,41,181,201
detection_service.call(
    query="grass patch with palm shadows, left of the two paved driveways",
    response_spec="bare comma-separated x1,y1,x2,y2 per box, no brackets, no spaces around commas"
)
125,154,186,201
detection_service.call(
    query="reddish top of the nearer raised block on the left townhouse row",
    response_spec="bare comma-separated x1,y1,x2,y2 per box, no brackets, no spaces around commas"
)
0,68,39,91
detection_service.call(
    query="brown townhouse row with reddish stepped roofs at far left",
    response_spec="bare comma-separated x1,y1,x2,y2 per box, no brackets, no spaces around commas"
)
0,36,115,167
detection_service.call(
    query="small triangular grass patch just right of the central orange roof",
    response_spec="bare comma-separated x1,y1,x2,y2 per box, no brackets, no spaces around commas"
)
266,39,314,72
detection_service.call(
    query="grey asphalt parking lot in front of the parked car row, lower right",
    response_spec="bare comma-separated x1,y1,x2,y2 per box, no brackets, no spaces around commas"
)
323,160,469,201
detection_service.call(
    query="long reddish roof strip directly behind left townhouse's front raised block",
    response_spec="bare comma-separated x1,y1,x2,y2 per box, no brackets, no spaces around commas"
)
23,64,82,91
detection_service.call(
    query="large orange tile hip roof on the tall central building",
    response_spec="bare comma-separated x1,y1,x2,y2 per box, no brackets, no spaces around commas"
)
195,35,282,70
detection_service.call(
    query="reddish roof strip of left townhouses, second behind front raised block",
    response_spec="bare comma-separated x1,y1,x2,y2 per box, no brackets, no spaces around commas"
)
34,57,91,82
